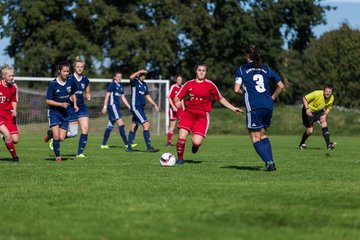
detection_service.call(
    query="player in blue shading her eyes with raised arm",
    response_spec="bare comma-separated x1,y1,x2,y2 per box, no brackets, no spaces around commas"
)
126,69,159,152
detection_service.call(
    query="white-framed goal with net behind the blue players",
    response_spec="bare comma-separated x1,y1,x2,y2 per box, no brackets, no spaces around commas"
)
15,77,169,135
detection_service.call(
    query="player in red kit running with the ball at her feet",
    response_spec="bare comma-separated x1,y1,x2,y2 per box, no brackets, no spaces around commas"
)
175,63,243,164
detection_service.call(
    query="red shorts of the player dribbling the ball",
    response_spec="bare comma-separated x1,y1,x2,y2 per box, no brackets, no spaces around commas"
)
178,109,210,137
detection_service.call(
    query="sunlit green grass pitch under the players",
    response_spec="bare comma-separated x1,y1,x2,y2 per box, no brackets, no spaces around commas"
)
0,134,360,240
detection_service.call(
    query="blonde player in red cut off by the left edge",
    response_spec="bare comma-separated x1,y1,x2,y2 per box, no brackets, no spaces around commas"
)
0,65,19,162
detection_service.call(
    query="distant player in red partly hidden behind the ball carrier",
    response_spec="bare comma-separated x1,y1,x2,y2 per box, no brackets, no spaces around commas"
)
166,75,185,147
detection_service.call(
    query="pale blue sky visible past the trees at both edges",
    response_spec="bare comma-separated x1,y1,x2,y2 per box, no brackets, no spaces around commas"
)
0,0,360,65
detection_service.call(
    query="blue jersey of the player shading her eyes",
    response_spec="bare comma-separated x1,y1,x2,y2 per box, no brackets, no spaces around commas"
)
130,78,149,110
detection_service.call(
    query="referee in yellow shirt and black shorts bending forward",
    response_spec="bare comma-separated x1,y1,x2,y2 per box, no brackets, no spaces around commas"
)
299,85,336,150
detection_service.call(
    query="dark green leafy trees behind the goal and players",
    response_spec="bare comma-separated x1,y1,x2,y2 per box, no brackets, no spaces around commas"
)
0,0,360,107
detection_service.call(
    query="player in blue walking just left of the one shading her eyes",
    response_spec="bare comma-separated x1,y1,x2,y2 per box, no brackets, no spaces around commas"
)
101,72,137,149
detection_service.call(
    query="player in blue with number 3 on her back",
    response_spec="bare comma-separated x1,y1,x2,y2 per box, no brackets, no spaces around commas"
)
234,45,284,171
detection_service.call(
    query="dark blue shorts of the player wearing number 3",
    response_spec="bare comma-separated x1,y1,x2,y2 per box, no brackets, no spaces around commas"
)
246,108,272,131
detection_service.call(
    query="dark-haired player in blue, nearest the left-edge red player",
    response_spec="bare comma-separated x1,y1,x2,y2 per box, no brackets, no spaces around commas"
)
45,63,79,162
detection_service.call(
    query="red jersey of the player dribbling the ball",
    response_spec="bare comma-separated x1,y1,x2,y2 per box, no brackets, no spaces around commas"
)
176,79,222,112
